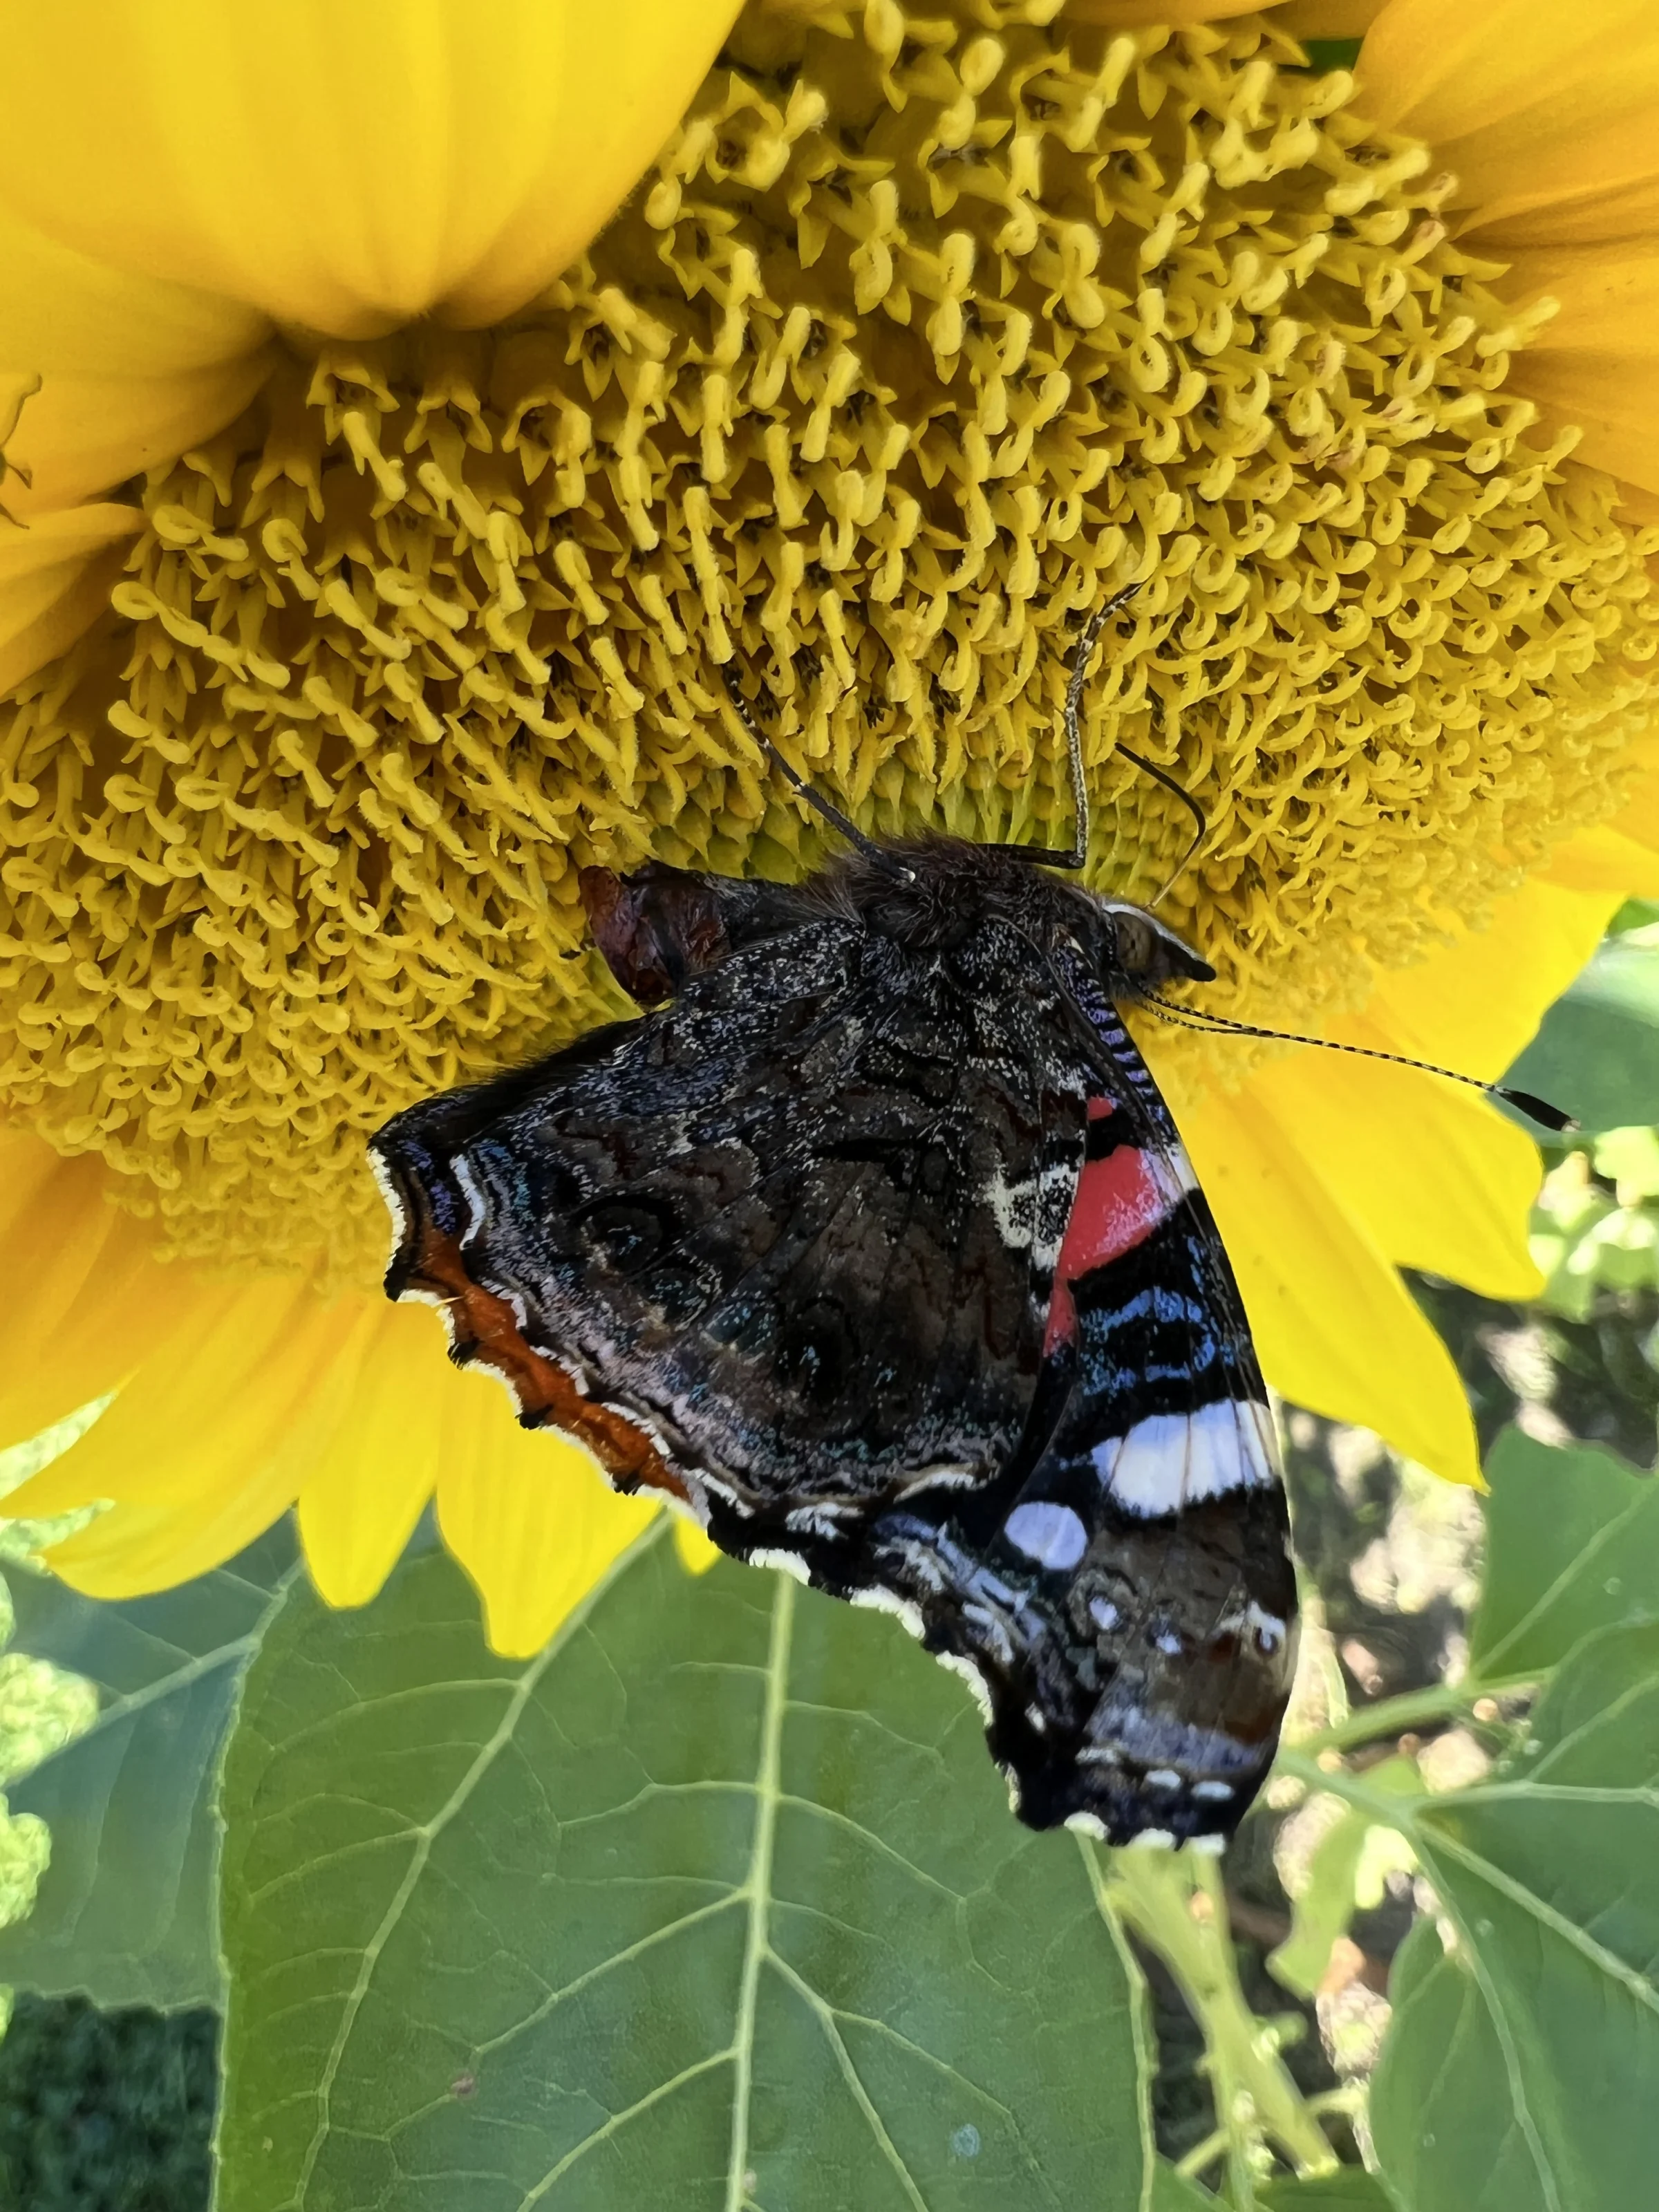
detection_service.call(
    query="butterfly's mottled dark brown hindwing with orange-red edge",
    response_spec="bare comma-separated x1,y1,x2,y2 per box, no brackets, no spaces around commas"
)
374,880,1086,1521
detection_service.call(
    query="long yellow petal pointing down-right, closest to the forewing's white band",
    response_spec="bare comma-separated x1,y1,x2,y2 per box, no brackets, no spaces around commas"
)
1181,1082,1480,1484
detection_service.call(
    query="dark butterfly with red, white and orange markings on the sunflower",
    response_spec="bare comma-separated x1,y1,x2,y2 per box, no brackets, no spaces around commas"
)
372,601,1296,1843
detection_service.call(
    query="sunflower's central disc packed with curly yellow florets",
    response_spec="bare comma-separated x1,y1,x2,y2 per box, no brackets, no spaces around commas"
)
0,0,1659,1279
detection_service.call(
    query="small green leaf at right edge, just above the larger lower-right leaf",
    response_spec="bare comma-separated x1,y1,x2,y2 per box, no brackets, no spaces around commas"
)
1469,1429,1659,1681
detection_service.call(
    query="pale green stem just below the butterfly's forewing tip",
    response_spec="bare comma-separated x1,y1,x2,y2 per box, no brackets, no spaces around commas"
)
1097,1849,1336,2185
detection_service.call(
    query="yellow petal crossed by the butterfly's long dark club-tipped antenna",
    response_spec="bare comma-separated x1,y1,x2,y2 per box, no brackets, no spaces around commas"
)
1250,1053,1544,1298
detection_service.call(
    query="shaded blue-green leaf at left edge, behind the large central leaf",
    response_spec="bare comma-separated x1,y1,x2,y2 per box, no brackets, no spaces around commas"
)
0,1526,294,2009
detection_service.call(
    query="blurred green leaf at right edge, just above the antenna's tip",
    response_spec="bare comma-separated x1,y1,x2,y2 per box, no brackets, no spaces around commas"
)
1504,929,1659,1130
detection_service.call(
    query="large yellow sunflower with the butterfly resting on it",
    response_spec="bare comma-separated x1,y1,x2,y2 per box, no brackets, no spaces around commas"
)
0,0,1659,1652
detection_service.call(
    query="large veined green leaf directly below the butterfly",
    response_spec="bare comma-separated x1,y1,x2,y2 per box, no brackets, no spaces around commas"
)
219,1524,1146,2212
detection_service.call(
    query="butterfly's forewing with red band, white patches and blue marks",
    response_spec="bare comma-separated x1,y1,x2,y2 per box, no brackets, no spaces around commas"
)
787,964,1296,1843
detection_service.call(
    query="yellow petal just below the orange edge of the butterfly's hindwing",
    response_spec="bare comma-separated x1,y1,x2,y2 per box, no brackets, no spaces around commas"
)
442,1362,657,1659
